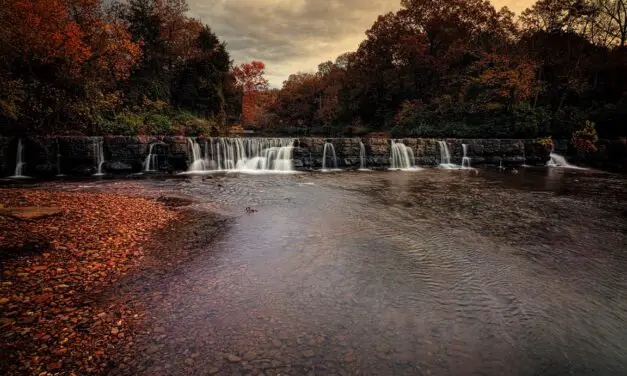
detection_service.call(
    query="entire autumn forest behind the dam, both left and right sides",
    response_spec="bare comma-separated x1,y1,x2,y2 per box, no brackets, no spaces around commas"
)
0,0,627,138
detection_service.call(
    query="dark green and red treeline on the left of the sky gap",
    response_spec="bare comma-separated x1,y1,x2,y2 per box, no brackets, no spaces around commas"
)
0,0,241,134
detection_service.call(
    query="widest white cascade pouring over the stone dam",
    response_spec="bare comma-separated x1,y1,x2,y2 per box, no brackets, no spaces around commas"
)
188,137,294,173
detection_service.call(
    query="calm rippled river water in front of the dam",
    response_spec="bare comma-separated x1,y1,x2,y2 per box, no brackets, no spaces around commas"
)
75,169,627,375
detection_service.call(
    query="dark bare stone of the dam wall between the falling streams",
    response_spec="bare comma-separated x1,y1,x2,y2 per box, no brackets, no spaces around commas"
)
0,136,627,177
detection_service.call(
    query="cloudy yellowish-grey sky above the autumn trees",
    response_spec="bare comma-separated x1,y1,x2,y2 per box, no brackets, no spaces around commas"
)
188,0,534,88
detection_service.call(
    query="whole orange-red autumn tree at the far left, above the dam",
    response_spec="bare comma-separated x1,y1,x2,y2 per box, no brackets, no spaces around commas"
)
0,0,139,132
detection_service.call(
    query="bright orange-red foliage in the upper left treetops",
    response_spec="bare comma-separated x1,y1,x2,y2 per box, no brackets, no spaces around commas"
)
5,0,140,79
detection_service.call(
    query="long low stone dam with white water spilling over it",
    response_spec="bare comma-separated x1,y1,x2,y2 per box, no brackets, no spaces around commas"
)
0,136,627,177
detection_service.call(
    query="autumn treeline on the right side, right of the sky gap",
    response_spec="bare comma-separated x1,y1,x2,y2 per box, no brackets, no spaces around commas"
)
257,0,627,138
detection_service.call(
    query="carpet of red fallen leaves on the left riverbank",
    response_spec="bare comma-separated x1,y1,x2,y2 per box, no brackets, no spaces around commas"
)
0,189,176,375
